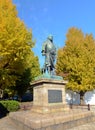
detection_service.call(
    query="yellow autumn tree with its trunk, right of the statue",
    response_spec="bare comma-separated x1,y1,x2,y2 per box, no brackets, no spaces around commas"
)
56,27,95,104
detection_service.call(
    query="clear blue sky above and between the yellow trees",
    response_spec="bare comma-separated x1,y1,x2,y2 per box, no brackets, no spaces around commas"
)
13,0,95,66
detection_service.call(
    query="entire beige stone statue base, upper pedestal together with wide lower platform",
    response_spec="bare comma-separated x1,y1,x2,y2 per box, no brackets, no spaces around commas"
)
9,79,95,130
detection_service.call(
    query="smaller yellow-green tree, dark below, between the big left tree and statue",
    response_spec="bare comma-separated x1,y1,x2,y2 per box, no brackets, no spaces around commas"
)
14,52,40,97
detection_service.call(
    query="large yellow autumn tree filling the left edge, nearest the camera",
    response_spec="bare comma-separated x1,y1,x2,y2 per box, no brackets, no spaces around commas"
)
0,0,39,96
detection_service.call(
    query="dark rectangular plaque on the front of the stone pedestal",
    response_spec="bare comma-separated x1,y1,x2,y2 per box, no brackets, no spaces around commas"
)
48,90,62,103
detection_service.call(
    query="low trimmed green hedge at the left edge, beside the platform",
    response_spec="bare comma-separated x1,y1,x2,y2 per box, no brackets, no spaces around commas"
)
0,100,19,112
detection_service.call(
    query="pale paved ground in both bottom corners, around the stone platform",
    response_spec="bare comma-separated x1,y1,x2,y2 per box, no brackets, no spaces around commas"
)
0,116,95,130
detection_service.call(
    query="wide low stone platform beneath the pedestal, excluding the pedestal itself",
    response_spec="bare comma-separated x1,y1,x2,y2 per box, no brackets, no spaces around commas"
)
9,110,95,130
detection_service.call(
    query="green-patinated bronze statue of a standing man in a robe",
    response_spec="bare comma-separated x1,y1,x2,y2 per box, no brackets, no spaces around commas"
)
41,35,56,74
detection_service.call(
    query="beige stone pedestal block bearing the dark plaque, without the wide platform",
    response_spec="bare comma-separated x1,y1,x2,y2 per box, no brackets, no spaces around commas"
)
31,79,69,113
